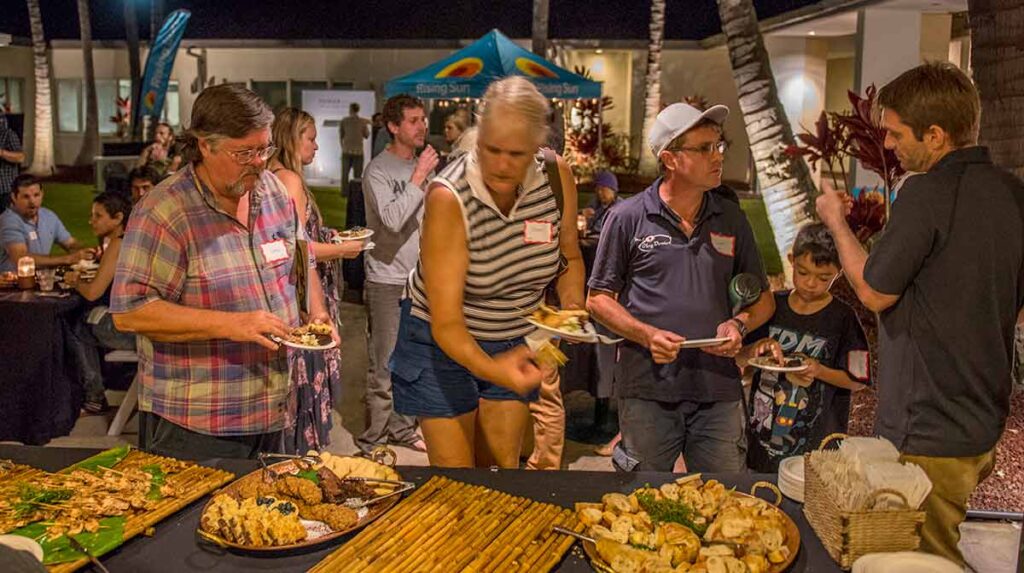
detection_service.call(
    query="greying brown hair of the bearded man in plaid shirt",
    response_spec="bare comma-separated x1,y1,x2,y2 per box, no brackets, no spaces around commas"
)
180,84,273,163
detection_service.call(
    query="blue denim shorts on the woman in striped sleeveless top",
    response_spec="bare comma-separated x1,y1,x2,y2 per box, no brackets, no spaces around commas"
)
389,299,538,417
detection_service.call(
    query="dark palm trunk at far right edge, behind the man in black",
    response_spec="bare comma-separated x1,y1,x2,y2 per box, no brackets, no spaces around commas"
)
968,0,1024,384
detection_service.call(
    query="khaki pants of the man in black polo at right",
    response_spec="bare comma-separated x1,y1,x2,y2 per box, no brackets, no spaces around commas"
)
901,448,995,565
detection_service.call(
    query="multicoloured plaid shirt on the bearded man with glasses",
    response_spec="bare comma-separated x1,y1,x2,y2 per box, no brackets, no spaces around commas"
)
111,166,302,436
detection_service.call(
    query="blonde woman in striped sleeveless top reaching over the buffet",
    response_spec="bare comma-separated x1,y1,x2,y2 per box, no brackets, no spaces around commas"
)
391,77,584,468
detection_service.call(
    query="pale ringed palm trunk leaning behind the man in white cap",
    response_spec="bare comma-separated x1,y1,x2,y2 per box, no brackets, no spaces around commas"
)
717,0,816,281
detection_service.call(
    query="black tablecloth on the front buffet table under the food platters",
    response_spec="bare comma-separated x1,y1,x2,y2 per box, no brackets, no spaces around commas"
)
0,445,840,573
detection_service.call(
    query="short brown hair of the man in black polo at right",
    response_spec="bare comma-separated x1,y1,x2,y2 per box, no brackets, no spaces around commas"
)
879,61,981,147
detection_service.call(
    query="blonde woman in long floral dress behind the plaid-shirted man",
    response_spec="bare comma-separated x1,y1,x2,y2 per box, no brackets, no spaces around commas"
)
267,107,362,453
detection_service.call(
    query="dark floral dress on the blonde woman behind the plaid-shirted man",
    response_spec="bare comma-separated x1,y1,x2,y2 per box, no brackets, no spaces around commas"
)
285,191,341,453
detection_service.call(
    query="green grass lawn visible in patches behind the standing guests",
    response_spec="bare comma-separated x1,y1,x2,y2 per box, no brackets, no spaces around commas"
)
36,183,782,274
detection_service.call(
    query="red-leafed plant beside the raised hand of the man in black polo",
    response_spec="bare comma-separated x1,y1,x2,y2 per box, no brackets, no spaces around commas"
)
785,84,904,244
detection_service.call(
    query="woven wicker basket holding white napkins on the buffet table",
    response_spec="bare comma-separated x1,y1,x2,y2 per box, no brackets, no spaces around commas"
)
804,434,925,570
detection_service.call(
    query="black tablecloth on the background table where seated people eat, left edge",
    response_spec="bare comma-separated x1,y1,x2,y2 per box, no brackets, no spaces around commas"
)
0,291,82,444
